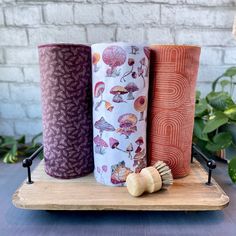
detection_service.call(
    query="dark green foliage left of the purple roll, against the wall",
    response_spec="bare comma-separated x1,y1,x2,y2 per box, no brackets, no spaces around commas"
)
0,133,42,163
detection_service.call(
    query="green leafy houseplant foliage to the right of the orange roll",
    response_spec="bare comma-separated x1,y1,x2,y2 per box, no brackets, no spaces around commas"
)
193,67,236,183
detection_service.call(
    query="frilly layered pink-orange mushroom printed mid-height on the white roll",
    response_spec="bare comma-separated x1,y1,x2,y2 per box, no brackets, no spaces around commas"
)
116,113,137,139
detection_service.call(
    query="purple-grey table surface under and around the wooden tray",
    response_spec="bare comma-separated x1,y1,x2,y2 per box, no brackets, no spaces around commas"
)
0,158,236,236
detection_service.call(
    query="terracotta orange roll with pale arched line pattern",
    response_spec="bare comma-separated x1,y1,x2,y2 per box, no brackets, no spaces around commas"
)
148,45,201,178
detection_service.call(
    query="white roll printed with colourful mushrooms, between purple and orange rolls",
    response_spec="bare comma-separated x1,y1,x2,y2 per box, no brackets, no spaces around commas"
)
92,43,150,186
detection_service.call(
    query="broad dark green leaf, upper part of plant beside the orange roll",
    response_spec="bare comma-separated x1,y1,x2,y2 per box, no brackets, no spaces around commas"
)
206,92,234,111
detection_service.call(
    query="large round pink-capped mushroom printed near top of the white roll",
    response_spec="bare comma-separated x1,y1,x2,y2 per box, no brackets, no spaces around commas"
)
102,45,126,77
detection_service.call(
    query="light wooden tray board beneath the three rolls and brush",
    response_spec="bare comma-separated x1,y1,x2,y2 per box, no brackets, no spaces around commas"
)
13,159,229,211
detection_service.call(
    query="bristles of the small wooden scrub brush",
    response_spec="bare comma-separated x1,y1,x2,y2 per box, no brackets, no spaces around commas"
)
154,161,173,189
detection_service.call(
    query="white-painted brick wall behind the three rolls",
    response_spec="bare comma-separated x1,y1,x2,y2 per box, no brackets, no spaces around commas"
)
0,0,236,137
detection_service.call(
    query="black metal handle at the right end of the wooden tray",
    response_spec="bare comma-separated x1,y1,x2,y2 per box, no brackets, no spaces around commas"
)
191,143,216,185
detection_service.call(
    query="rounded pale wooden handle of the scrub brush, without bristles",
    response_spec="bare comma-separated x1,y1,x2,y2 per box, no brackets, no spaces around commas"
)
126,166,162,197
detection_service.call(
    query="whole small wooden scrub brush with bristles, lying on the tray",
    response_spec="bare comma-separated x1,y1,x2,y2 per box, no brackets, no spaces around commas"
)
126,161,173,197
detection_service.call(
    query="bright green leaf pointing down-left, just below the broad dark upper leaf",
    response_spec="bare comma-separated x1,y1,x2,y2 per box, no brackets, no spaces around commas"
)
203,111,229,133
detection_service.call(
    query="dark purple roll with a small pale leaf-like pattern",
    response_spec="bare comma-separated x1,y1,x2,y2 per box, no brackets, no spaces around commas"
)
39,44,94,179
